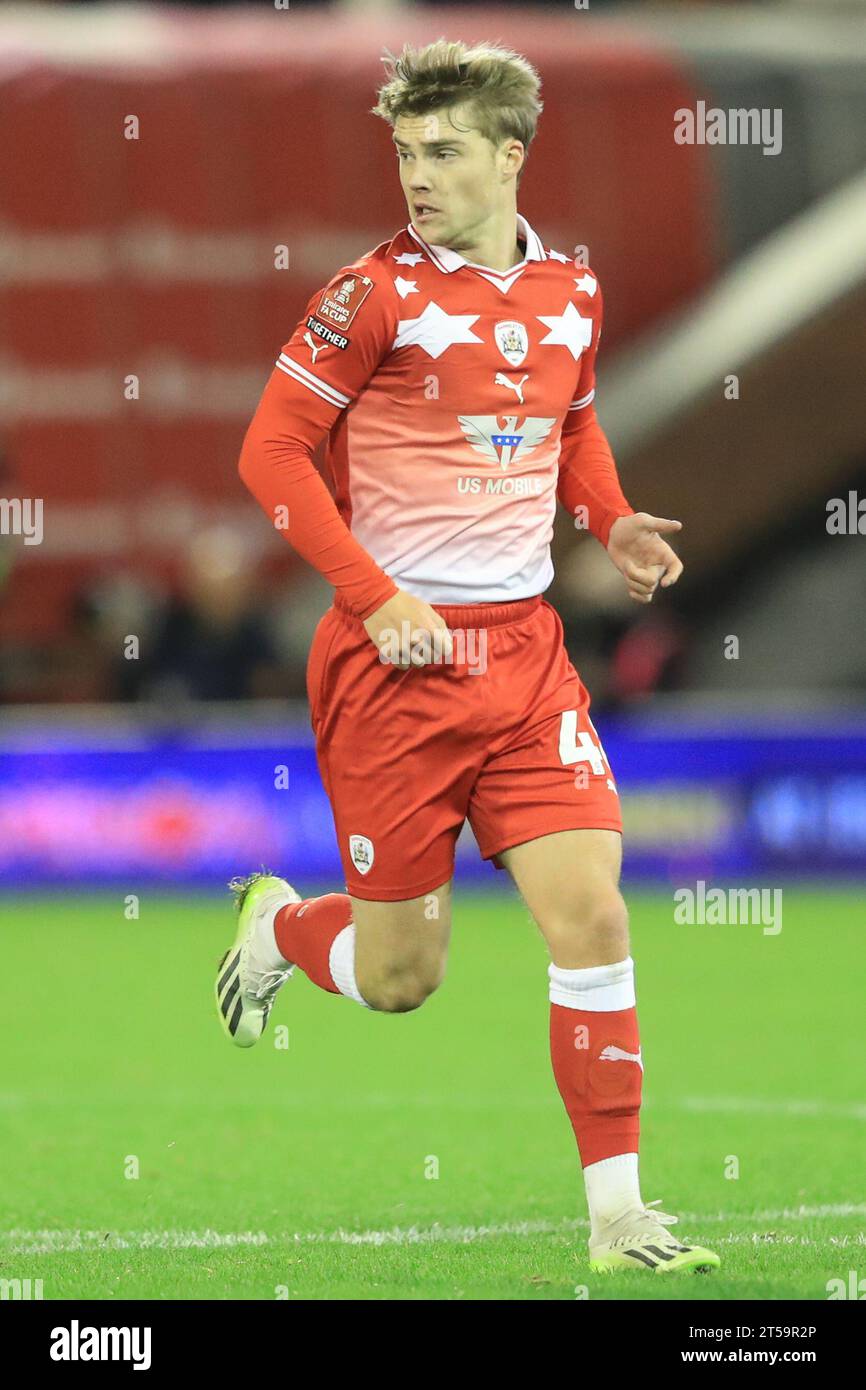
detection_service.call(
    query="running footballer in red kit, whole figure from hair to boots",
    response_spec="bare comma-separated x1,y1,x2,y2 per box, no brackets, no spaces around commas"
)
215,39,719,1273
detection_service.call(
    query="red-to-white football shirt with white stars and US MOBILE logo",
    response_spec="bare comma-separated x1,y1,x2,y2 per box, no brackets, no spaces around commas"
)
240,209,631,617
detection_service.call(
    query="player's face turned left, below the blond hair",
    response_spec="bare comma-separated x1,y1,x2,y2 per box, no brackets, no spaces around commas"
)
393,106,523,250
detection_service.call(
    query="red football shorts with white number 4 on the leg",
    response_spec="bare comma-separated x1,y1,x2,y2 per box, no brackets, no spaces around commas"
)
307,598,623,902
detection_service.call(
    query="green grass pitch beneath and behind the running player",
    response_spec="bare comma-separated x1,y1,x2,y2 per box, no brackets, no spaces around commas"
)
0,884,866,1301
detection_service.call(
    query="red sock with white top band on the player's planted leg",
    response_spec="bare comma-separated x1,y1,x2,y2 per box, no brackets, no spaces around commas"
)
550,959,644,1168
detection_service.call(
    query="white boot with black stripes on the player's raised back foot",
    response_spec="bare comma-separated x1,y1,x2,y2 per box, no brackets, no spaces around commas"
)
214,872,302,1047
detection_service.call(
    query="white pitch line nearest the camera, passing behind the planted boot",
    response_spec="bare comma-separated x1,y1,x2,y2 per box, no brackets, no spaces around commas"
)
0,1202,866,1255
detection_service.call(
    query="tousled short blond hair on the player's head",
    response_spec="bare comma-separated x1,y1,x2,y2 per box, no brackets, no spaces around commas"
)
373,39,544,182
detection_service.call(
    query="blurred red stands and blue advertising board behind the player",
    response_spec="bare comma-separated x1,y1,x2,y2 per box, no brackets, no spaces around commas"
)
0,0,866,888
